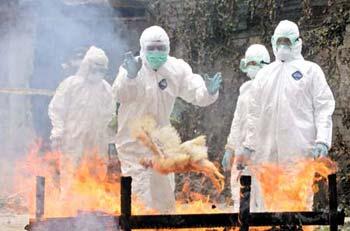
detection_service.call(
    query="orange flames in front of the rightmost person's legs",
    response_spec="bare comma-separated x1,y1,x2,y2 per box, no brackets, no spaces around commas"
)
252,158,336,212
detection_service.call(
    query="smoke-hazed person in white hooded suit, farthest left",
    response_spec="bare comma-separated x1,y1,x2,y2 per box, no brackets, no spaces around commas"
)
48,46,115,165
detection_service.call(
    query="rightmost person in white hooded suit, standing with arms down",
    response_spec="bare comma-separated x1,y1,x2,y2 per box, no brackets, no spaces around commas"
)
236,20,335,209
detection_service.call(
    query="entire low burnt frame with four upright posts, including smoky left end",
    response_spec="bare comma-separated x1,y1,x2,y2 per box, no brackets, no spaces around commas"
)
25,174,345,231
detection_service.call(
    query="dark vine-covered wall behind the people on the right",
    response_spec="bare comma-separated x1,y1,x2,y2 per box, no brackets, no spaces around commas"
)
150,0,350,209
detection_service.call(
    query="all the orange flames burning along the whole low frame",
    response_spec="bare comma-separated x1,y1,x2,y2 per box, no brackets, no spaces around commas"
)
10,144,336,230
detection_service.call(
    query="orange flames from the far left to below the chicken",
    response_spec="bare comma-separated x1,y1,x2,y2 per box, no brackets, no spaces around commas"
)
14,144,222,217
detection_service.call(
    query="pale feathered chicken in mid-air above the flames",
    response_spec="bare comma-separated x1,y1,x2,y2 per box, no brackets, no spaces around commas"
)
131,116,224,192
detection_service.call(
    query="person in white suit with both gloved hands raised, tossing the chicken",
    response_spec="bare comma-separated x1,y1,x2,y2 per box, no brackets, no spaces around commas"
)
113,26,222,213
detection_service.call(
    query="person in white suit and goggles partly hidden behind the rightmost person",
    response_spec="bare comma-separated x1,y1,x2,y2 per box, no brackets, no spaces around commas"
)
222,44,270,212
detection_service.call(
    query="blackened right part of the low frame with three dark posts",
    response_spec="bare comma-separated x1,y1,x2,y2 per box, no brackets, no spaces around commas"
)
120,174,345,231
